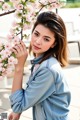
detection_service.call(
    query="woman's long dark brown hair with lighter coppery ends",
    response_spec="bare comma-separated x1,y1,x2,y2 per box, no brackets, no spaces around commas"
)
30,11,68,67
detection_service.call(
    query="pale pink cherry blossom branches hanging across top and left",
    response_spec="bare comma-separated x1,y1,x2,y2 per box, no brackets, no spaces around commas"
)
0,0,66,79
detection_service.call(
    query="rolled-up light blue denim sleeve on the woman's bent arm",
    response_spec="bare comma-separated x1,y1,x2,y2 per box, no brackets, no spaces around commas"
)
10,68,55,113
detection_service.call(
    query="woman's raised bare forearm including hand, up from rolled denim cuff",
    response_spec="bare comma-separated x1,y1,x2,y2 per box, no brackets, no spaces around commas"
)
12,41,28,92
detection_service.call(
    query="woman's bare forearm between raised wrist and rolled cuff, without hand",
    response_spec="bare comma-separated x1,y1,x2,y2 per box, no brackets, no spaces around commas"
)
12,67,24,92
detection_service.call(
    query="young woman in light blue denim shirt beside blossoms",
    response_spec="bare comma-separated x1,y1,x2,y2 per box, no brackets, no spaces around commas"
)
9,11,71,120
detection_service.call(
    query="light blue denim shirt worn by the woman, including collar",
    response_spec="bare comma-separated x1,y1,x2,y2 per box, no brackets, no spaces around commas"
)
10,56,71,120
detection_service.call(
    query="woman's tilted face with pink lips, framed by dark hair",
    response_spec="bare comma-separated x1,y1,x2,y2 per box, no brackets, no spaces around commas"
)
31,24,55,57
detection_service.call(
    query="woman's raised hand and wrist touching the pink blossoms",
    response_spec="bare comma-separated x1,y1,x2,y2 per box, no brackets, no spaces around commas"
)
12,41,28,68
